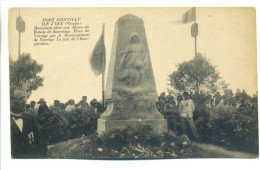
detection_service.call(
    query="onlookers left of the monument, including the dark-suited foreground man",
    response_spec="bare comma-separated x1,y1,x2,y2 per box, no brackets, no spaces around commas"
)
10,87,104,158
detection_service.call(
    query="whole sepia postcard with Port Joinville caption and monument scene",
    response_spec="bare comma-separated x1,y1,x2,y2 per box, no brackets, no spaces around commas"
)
8,7,259,160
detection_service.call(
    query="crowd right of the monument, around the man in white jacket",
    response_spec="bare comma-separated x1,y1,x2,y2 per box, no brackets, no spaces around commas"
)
157,91,253,141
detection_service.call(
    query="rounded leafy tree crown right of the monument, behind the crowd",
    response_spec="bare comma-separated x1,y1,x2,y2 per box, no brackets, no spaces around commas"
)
169,53,227,93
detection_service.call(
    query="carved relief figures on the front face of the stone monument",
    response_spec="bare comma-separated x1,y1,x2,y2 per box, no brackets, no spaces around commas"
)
118,32,148,87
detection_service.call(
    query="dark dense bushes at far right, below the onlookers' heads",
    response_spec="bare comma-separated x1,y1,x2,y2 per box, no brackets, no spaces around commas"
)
202,99,258,154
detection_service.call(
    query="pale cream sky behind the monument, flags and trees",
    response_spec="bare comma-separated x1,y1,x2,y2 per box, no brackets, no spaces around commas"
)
9,8,257,104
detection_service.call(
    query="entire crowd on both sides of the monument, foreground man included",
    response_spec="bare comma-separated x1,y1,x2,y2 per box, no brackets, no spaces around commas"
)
10,84,254,158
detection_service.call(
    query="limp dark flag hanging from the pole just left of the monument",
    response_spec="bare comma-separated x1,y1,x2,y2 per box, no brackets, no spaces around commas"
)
89,24,106,76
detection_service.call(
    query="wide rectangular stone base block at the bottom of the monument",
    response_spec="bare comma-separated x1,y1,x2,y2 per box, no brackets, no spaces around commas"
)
97,119,167,136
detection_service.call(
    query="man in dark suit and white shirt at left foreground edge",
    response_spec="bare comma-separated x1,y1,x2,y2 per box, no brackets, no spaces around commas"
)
10,87,47,158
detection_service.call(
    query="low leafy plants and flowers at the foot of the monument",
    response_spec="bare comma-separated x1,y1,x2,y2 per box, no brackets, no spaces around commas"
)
97,124,193,159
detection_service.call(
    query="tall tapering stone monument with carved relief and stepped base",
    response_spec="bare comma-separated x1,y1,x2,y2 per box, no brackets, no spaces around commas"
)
97,14,167,136
